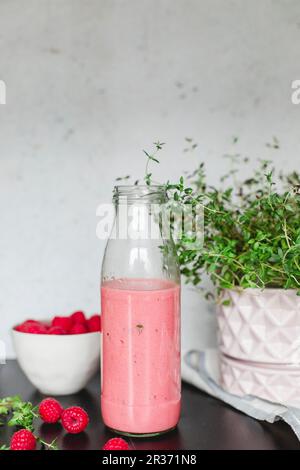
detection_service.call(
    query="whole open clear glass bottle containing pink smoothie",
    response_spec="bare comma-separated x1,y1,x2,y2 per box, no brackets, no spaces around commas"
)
101,186,181,435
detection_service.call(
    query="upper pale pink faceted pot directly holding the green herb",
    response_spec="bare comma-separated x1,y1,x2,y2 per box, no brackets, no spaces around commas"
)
218,289,300,367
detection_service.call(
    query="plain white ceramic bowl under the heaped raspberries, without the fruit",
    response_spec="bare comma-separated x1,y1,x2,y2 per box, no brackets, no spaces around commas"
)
12,329,101,395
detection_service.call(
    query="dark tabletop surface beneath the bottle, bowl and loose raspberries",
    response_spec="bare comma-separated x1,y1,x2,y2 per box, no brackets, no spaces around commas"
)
0,361,300,450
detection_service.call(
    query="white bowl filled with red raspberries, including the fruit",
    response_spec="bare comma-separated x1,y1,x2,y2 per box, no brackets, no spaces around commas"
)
12,311,101,395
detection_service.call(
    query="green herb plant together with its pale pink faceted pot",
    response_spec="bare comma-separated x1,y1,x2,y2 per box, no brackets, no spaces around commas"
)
169,159,300,405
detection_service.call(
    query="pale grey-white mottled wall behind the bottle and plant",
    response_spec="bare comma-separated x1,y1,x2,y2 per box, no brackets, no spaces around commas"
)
0,0,300,355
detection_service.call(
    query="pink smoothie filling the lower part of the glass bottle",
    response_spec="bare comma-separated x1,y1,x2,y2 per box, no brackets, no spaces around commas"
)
101,279,181,434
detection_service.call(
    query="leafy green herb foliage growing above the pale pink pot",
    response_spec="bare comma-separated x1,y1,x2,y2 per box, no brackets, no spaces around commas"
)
167,156,300,297
